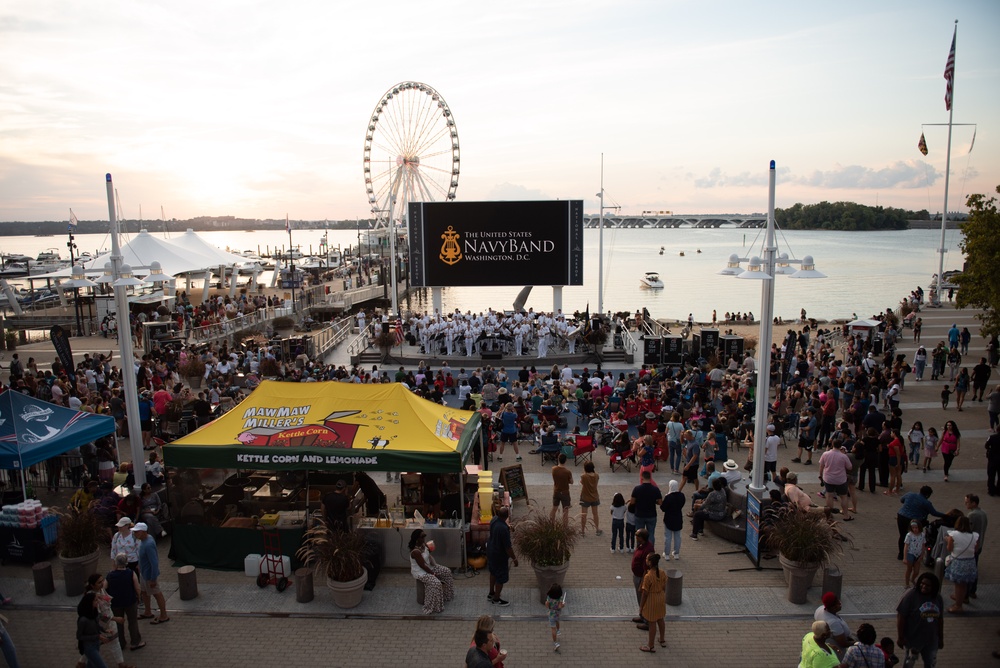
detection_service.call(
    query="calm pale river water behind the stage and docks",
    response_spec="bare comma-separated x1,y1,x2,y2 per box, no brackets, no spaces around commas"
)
0,228,962,321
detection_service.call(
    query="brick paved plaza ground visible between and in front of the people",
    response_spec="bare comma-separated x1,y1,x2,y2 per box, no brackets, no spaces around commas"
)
0,308,1000,668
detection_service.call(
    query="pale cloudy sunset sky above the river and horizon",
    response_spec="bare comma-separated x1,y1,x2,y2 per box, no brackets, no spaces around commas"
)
0,0,1000,221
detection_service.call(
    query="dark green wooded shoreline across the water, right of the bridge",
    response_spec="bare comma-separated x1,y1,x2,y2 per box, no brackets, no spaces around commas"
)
774,202,931,231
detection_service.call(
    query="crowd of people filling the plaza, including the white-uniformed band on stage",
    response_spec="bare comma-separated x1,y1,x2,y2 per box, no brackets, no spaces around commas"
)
3,280,1000,667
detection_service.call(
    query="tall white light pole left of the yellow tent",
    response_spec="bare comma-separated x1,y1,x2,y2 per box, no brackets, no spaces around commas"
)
105,174,146,494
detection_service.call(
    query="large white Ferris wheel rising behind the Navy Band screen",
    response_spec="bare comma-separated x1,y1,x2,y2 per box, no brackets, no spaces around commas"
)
364,81,459,228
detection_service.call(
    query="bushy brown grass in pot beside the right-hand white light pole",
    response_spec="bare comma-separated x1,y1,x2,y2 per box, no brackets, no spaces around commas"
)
762,505,844,603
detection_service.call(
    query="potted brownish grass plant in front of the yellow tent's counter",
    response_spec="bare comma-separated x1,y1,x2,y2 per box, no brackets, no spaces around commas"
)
295,520,368,608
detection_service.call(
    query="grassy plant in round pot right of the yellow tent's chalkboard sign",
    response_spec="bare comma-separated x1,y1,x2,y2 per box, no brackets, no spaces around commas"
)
512,510,580,603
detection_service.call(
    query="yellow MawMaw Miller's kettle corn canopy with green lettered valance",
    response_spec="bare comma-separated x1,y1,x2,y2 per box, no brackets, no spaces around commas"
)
163,381,480,473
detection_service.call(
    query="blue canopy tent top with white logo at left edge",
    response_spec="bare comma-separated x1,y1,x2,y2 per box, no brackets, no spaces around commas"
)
0,390,115,495
